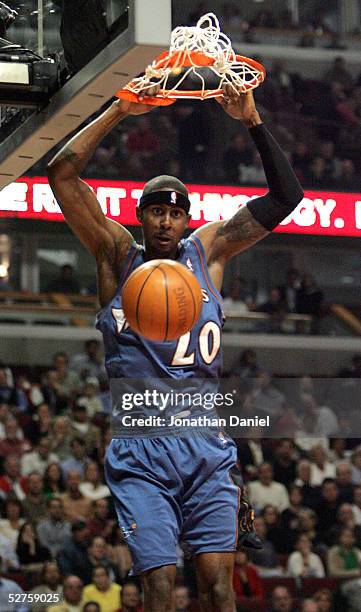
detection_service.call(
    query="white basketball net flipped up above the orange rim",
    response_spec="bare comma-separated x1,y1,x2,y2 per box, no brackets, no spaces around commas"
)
125,13,264,99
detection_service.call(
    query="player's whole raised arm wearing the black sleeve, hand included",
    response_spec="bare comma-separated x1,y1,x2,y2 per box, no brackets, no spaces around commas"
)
193,87,303,266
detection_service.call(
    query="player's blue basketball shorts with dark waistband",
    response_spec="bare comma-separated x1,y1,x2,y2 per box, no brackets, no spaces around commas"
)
105,432,239,574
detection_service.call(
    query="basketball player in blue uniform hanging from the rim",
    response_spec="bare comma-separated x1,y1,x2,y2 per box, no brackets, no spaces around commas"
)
49,88,303,612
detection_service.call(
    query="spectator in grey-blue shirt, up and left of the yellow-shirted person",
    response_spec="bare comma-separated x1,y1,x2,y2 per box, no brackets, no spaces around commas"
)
37,497,71,559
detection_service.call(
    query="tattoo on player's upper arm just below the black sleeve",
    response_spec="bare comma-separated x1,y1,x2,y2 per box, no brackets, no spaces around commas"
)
216,206,269,245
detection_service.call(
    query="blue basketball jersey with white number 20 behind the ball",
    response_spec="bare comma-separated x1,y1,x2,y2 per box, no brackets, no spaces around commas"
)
96,234,224,437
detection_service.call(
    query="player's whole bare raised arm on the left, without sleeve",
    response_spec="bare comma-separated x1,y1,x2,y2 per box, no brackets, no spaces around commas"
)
48,92,158,260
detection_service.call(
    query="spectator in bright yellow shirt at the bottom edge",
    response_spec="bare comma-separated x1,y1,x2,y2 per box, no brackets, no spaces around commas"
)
83,565,122,612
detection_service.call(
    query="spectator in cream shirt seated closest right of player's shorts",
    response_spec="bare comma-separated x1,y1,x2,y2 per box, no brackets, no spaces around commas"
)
248,463,290,512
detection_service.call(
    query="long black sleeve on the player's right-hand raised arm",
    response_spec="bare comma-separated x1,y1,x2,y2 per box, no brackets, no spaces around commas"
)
247,123,303,232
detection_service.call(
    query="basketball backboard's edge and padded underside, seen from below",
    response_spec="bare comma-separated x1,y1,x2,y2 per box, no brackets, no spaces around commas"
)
0,0,171,190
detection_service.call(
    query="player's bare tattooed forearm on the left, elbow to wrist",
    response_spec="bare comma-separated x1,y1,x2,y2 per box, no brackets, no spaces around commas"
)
48,102,128,180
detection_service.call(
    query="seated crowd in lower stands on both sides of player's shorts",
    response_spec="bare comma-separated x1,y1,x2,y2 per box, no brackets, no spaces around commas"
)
0,341,361,612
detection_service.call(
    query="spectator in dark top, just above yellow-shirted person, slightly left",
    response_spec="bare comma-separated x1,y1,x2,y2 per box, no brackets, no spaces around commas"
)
57,521,91,583
